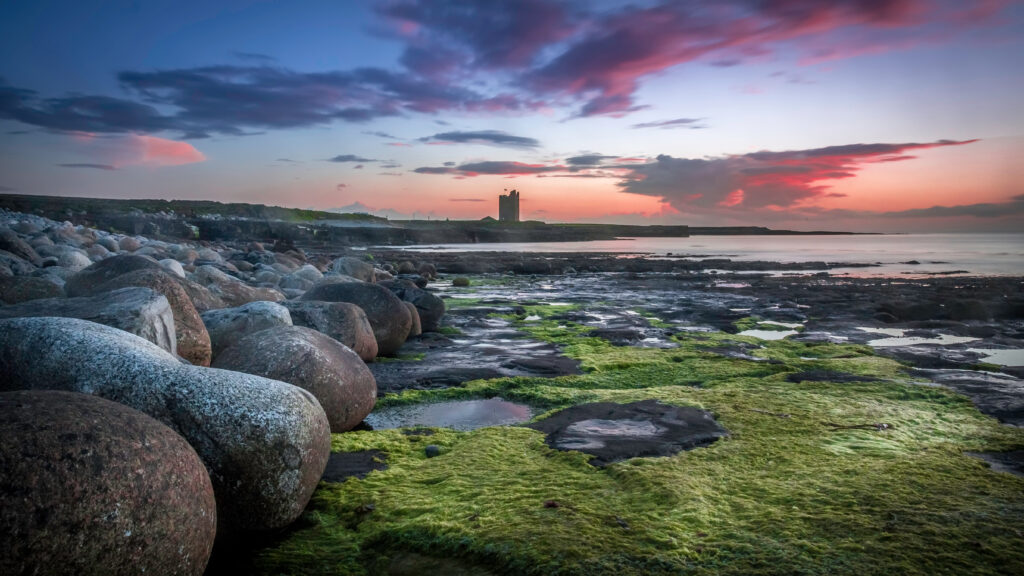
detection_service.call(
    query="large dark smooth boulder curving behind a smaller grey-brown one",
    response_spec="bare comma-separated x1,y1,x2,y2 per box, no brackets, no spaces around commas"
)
301,282,413,356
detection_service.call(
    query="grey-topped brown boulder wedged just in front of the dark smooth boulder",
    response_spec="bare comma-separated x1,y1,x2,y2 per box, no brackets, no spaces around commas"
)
282,300,377,362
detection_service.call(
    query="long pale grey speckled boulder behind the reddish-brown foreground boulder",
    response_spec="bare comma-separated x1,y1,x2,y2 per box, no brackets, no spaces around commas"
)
0,315,331,530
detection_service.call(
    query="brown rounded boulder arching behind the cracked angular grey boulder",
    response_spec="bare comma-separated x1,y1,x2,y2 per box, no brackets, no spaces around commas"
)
68,268,211,366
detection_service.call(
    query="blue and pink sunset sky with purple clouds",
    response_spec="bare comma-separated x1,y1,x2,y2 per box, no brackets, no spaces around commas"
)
0,0,1024,232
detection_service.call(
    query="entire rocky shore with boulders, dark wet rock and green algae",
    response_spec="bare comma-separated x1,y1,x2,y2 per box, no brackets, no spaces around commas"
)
0,207,1024,574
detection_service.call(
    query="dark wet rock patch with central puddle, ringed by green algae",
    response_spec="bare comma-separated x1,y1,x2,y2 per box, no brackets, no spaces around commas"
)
527,400,728,466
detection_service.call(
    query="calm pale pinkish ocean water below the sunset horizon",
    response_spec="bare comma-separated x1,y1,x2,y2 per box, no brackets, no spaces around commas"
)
397,234,1024,276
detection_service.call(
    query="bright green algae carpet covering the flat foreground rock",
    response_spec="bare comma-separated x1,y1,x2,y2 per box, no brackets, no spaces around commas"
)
256,297,1024,576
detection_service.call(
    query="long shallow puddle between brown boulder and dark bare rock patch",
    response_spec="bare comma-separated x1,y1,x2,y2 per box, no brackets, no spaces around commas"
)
366,398,534,430
